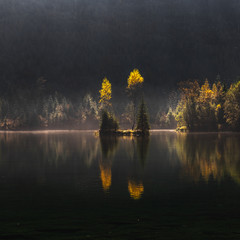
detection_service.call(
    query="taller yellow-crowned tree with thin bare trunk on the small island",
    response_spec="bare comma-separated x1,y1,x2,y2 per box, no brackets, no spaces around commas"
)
127,69,144,129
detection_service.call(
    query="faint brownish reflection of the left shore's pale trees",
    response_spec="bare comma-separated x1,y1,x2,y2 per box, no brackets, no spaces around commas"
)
0,132,99,182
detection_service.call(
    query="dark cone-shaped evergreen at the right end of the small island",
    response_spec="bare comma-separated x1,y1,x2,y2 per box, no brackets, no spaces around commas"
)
136,99,150,133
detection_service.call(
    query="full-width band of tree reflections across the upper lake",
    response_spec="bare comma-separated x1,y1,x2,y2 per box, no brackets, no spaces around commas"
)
0,132,240,200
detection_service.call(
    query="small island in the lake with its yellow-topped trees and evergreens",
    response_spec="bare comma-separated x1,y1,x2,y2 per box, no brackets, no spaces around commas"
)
96,69,150,136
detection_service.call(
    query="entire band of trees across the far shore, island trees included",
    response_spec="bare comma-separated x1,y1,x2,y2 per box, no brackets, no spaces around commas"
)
0,73,240,131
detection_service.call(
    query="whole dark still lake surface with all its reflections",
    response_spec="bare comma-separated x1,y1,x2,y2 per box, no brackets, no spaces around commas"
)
0,132,240,240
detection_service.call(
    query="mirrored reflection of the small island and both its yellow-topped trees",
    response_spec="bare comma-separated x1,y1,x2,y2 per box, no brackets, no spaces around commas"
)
99,136,149,200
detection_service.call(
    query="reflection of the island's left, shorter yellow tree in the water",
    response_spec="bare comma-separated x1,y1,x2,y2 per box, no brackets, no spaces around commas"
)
99,136,118,191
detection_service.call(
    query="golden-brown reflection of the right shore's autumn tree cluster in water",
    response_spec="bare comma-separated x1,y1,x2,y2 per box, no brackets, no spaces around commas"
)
176,134,240,182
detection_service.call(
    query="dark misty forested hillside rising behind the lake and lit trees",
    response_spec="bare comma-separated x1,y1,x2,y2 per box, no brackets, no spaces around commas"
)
0,0,240,128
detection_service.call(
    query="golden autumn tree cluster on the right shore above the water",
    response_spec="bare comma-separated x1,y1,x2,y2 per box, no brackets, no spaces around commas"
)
174,79,240,131
